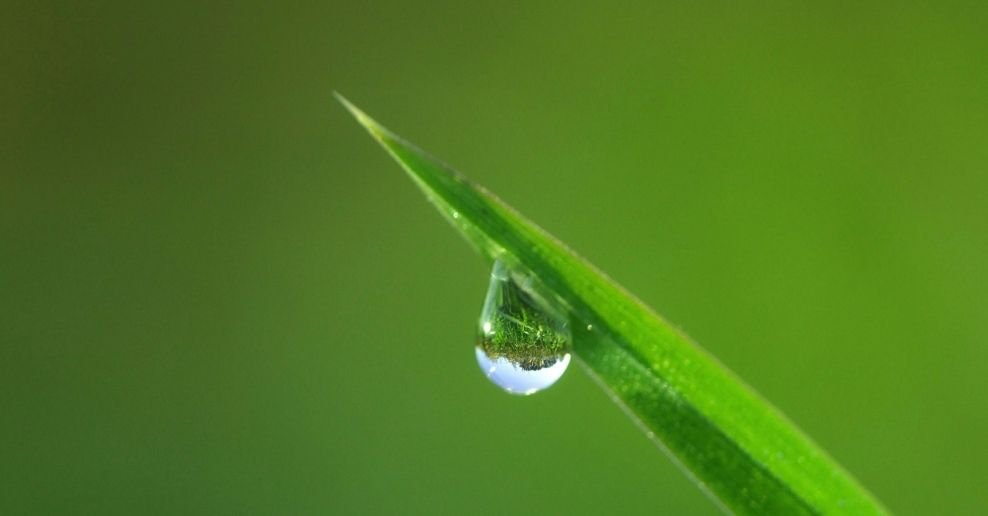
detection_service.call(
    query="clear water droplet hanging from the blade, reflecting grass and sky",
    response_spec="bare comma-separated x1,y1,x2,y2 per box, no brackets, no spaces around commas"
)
475,260,570,395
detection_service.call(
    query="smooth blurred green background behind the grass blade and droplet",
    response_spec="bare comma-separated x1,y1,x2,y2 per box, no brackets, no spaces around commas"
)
0,0,988,514
